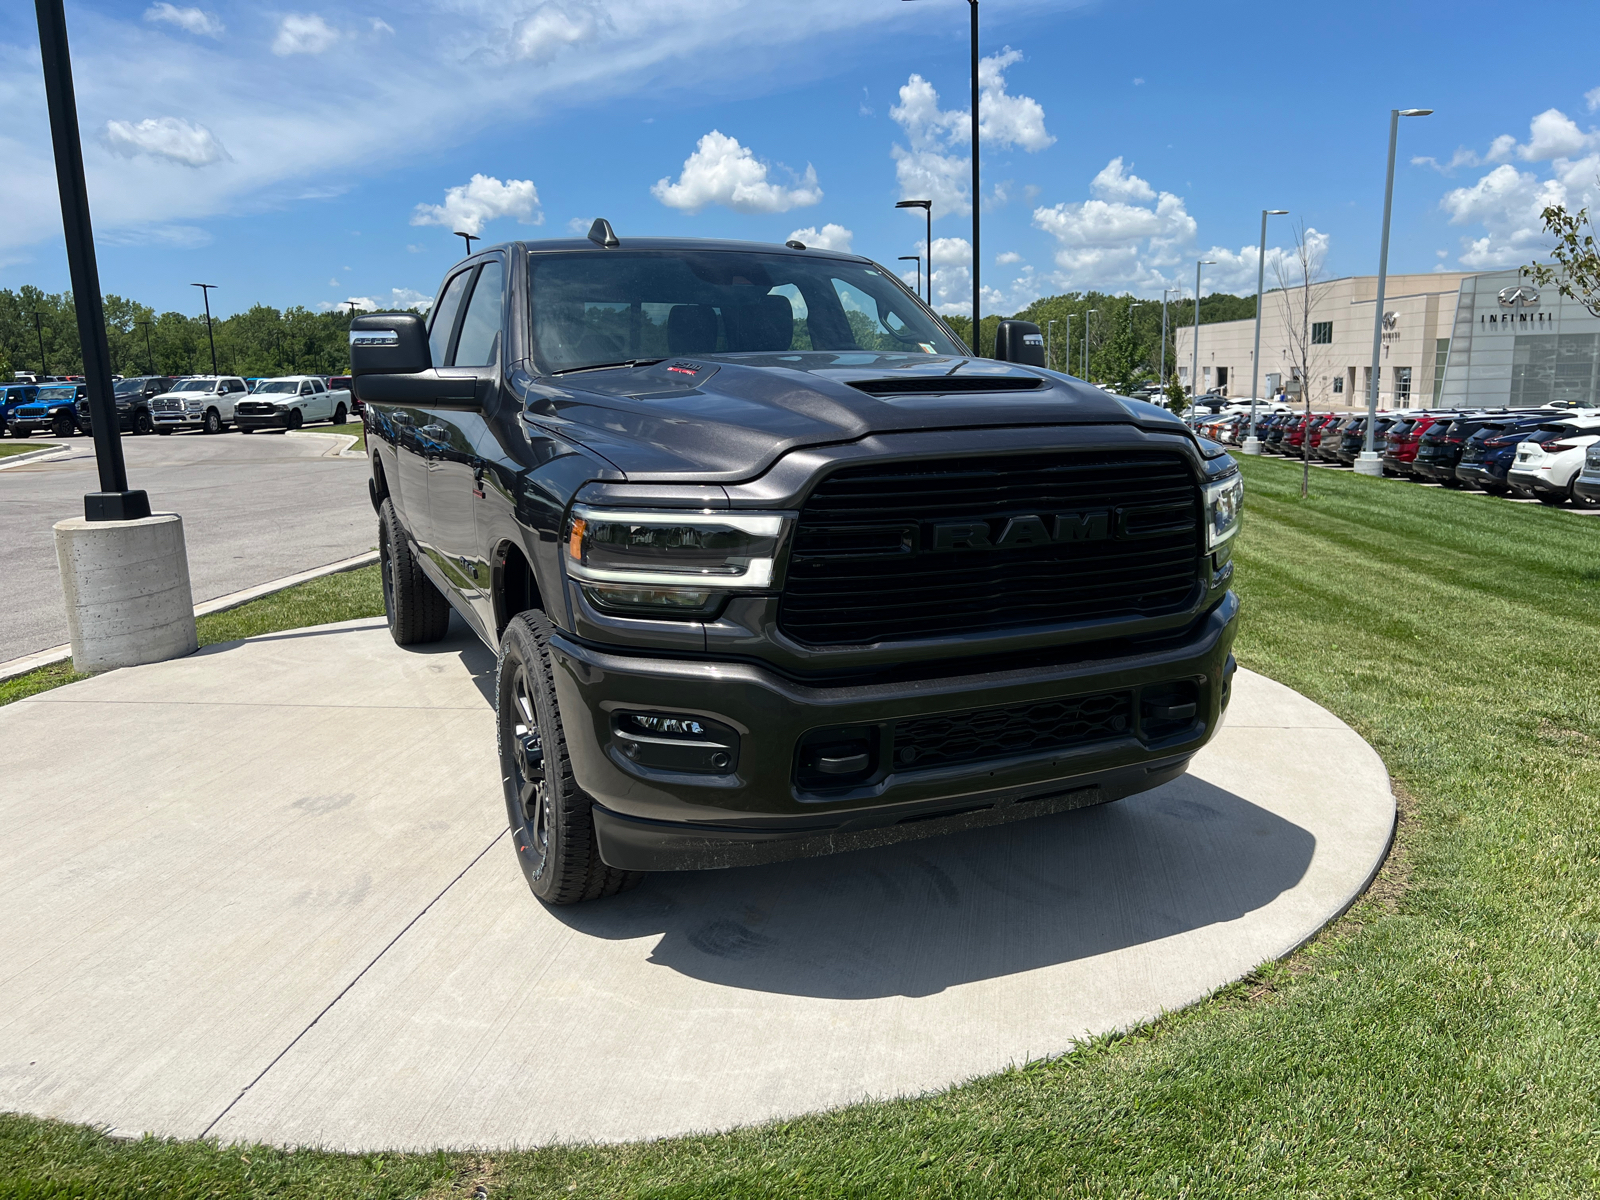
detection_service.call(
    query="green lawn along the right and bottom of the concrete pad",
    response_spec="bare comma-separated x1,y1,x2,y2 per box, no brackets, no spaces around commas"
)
0,461,1600,1200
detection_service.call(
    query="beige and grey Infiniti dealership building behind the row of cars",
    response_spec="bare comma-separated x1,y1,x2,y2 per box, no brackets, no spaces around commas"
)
1176,267,1600,410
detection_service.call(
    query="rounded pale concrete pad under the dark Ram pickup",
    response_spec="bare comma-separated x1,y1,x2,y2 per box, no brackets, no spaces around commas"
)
0,621,1395,1149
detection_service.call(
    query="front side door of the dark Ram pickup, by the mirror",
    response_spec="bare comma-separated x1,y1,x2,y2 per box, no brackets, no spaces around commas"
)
427,258,506,635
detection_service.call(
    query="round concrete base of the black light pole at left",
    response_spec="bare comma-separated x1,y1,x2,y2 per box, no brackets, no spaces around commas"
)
54,512,200,672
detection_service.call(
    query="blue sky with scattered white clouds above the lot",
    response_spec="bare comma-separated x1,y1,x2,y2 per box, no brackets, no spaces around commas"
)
0,0,1600,314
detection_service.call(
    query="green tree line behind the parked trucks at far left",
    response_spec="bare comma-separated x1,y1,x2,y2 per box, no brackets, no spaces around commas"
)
0,285,419,378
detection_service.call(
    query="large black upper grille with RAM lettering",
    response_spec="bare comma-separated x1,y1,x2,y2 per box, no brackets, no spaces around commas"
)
778,451,1202,645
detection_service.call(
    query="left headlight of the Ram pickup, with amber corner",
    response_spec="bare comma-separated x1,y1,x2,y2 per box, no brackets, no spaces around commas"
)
563,504,789,616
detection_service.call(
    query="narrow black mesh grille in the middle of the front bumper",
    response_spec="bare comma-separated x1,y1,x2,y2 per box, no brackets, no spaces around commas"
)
894,691,1133,771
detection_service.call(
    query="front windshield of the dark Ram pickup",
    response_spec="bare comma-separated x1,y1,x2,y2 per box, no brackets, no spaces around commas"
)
528,250,966,371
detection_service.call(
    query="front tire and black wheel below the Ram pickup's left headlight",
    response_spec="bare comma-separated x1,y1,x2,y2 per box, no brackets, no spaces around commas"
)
494,611,645,904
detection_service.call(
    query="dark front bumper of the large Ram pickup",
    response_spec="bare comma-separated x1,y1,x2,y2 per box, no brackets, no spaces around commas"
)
550,592,1238,870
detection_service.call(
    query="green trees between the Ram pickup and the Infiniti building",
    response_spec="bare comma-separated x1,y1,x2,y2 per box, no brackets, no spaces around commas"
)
946,291,1256,392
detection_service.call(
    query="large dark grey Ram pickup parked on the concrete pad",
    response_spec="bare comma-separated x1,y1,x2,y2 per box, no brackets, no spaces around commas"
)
350,221,1243,904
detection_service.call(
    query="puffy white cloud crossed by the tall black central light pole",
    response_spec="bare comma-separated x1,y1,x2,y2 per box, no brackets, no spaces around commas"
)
890,46,1056,216
